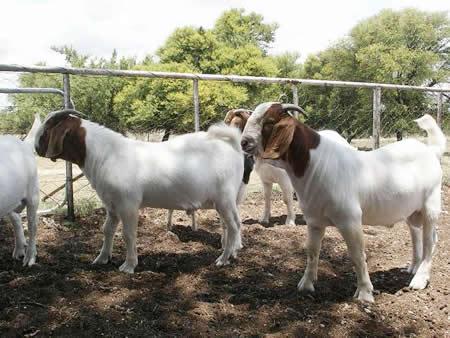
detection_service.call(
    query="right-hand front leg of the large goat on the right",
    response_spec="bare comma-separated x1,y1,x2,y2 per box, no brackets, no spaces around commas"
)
337,222,374,303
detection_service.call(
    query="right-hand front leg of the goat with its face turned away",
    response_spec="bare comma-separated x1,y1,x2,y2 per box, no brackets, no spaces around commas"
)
119,209,139,273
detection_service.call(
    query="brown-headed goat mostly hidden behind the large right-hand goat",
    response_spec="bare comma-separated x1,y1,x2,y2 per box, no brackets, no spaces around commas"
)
224,109,351,226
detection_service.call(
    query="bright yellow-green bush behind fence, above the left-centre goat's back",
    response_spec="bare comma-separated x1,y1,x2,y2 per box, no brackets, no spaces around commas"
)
115,63,247,134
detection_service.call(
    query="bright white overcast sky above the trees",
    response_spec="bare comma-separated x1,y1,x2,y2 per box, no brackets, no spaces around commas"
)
0,0,450,108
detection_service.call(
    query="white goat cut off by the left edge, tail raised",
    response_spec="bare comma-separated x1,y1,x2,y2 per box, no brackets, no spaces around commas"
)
0,114,41,266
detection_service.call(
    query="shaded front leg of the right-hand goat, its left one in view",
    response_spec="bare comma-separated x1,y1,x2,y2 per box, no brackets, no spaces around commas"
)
297,224,325,292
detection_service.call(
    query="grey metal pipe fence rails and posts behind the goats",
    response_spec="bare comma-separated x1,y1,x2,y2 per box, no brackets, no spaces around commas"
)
0,64,450,220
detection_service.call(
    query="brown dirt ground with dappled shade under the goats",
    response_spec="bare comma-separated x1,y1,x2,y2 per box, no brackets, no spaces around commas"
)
0,187,450,337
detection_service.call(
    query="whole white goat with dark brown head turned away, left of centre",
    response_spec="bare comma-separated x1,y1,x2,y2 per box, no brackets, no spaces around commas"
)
35,109,244,273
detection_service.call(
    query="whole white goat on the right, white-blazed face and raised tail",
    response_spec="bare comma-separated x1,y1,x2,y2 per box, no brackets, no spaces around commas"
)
241,102,446,302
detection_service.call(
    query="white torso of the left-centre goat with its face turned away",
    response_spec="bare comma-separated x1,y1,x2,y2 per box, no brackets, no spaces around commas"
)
81,120,243,210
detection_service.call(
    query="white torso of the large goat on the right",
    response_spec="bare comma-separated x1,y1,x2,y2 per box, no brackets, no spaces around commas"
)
290,137,442,225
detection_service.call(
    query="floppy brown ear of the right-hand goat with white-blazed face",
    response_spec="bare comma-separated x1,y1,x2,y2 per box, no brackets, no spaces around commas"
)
262,118,295,160
